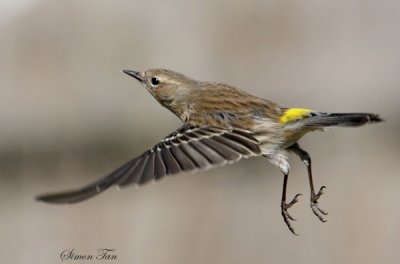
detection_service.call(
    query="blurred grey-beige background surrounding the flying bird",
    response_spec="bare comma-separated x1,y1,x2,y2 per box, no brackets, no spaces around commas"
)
0,0,400,264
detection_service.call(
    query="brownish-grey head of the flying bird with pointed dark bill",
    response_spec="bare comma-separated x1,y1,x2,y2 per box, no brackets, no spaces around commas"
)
123,69,199,110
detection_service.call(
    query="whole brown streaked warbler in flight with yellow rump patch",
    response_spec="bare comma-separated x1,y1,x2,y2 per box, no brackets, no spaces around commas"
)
37,69,382,234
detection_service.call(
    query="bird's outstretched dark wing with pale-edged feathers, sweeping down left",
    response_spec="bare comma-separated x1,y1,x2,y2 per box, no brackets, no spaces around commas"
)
36,125,261,203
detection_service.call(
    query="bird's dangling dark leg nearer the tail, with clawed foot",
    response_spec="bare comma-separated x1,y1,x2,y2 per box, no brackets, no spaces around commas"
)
290,143,328,222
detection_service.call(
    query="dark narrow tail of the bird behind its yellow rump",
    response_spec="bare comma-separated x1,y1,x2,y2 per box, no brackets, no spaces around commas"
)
305,113,384,127
